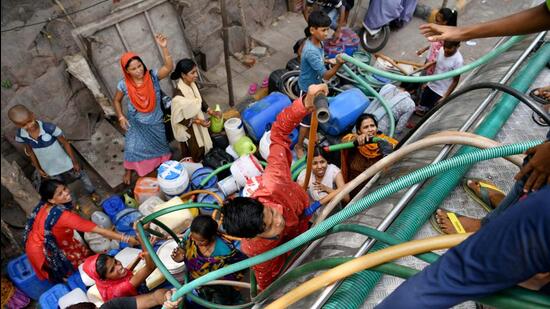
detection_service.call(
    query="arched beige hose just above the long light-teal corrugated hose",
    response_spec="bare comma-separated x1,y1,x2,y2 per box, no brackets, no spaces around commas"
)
314,131,523,225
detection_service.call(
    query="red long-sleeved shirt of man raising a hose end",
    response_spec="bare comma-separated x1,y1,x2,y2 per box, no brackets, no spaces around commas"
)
241,98,309,290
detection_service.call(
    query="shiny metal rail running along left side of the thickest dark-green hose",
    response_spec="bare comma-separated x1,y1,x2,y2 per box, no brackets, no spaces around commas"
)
311,31,546,309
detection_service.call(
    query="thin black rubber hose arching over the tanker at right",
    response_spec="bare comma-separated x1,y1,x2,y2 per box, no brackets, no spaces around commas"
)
396,82,550,149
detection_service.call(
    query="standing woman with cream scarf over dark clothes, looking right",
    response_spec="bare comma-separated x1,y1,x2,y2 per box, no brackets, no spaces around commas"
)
170,58,221,162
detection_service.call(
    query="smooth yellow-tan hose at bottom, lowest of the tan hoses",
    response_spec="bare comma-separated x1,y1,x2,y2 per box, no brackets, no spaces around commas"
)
266,233,472,309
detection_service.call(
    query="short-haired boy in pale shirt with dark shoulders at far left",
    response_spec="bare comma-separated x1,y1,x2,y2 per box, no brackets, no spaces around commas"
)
8,104,99,202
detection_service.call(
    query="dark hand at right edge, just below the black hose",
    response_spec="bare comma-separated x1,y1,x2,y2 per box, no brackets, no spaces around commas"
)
514,142,550,192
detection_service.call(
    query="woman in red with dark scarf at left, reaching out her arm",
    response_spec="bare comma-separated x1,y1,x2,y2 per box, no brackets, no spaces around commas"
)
24,180,137,282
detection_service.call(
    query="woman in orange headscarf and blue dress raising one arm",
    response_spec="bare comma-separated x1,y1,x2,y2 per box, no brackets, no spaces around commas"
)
113,34,174,185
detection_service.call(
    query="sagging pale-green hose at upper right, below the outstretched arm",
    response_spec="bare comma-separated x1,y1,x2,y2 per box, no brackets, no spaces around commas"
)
342,36,525,83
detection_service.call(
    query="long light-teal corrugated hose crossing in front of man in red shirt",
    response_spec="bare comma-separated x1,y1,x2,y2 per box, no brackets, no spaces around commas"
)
164,141,541,306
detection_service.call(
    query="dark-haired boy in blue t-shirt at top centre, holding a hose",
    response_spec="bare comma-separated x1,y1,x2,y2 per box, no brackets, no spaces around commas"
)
294,11,344,158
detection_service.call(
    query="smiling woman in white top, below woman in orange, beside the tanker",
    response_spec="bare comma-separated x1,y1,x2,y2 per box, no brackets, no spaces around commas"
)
296,146,349,205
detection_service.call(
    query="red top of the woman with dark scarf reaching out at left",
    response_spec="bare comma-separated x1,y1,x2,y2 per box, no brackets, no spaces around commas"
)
25,207,96,280
